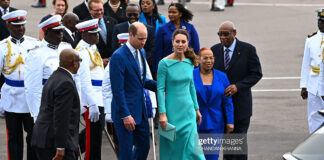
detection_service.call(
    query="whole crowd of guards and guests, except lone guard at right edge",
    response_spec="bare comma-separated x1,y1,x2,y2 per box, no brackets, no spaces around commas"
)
0,0,262,160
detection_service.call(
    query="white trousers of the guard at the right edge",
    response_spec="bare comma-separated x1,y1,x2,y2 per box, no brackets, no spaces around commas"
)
307,92,324,133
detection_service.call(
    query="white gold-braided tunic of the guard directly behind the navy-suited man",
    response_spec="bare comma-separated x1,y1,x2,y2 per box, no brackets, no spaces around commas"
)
76,40,104,112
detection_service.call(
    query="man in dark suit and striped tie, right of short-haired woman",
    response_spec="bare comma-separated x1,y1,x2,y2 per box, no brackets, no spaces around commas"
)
211,21,262,160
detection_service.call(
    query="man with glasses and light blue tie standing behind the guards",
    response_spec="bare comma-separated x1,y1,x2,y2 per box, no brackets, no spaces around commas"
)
86,0,117,66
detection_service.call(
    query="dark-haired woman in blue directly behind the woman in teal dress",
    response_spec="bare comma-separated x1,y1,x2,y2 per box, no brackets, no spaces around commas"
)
152,3,200,74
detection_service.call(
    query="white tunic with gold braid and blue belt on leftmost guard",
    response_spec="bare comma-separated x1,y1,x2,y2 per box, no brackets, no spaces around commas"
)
0,36,39,113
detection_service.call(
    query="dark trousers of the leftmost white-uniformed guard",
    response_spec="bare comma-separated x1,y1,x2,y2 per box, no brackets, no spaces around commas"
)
5,112,36,160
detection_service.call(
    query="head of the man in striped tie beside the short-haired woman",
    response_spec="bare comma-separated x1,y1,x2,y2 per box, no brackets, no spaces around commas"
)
218,21,236,47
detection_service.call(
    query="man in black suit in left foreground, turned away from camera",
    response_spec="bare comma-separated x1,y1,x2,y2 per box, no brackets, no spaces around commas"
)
32,49,82,160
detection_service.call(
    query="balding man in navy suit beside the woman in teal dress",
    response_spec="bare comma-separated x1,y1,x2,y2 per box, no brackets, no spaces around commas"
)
110,22,156,160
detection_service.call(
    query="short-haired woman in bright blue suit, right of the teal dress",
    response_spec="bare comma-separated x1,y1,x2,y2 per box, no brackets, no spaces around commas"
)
193,48,234,160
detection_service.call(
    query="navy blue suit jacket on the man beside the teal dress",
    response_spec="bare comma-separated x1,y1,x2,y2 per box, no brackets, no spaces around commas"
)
109,45,156,124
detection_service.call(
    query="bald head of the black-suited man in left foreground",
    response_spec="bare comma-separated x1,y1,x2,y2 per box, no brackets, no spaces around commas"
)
60,49,80,74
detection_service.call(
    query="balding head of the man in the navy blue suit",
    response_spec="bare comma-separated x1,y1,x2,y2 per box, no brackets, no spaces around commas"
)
128,22,147,49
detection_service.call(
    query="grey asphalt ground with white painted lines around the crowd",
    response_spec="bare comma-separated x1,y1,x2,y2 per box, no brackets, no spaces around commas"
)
0,0,324,160
